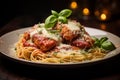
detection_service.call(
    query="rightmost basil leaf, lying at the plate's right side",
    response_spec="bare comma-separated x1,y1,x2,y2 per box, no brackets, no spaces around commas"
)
101,41,116,51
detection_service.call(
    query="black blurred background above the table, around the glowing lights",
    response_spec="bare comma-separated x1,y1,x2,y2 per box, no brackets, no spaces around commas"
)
0,0,120,27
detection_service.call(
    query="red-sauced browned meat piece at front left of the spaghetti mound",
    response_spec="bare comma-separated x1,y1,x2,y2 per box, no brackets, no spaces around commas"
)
32,34,57,52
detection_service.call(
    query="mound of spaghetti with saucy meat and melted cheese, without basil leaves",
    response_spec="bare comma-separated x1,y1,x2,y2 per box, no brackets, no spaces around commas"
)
16,21,107,63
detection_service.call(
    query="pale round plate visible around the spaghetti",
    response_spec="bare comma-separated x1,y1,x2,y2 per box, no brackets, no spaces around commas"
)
0,27,120,67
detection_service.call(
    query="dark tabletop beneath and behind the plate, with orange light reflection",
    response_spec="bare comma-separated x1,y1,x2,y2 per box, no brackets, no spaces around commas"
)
0,15,120,80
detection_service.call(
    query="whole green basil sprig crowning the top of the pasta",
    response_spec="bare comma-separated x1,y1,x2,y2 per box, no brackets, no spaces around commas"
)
45,9,72,28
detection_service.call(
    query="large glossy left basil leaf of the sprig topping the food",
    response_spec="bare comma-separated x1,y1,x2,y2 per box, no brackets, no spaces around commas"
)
45,15,57,28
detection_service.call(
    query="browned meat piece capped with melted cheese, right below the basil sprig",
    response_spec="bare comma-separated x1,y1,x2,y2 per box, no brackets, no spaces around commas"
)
55,20,80,42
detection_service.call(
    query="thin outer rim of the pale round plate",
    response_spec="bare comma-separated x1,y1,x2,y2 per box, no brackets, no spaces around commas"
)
0,27,120,66
